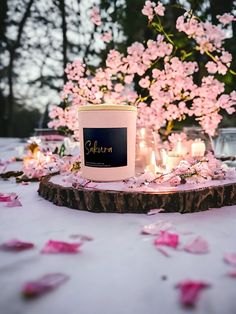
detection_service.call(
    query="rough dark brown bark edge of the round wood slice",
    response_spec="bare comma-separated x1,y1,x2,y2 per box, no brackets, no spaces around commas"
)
38,176,236,214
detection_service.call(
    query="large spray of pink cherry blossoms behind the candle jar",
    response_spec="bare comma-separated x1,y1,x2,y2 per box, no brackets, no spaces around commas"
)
49,1,236,135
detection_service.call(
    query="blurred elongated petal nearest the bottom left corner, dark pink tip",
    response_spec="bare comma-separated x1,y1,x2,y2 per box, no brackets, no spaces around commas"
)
22,273,69,298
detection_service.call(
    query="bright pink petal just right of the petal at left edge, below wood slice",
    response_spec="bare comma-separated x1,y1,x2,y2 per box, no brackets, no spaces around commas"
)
41,240,82,254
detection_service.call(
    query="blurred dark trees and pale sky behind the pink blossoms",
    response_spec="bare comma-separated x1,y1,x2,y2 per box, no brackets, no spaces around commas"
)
0,0,236,137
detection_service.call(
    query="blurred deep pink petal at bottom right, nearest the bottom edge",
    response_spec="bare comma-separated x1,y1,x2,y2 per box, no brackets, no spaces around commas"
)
176,280,210,306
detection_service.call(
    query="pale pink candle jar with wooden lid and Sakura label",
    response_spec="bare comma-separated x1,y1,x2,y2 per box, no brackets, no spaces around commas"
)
79,105,137,181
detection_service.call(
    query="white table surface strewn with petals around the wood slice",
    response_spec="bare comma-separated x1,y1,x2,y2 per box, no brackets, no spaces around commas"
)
0,139,236,314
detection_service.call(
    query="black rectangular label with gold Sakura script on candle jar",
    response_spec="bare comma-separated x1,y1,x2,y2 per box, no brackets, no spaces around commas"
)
83,128,127,168
